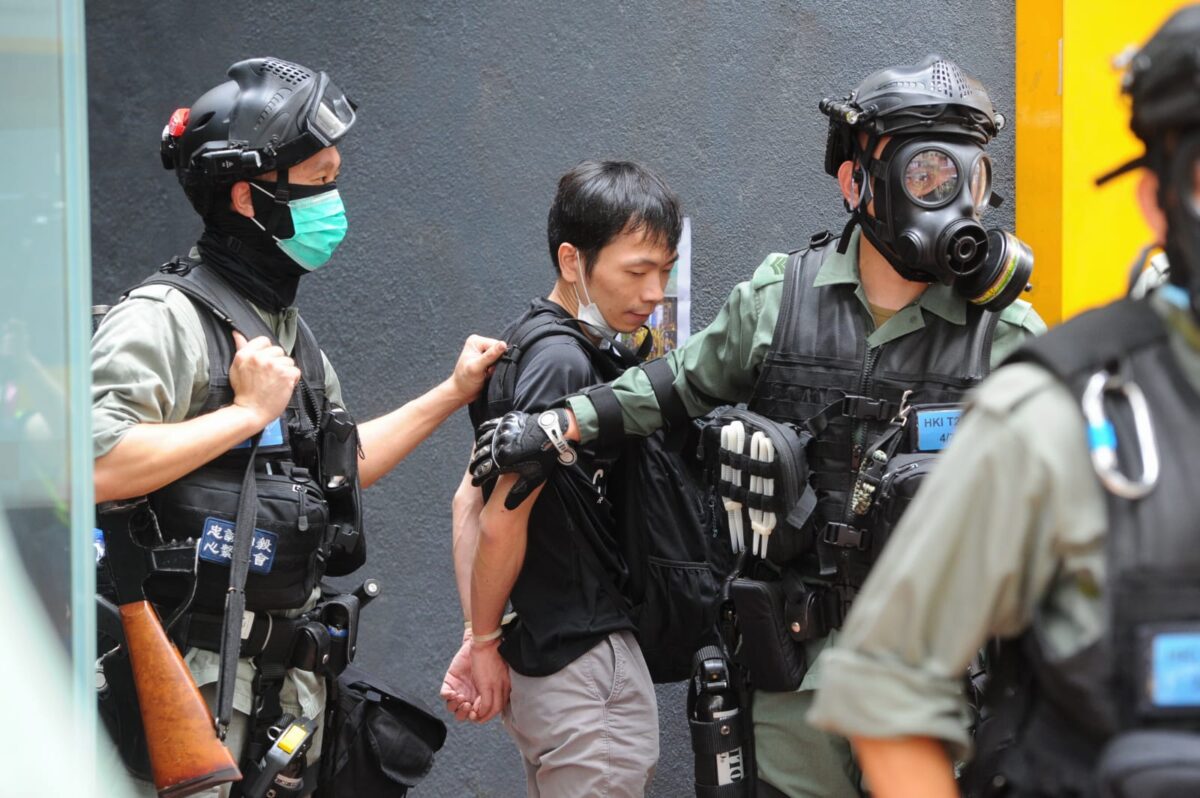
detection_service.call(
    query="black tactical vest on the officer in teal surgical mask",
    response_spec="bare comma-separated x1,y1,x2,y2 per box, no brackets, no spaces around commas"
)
116,259,365,614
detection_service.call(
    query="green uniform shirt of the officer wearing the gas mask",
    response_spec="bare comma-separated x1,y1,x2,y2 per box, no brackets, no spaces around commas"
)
568,230,1046,442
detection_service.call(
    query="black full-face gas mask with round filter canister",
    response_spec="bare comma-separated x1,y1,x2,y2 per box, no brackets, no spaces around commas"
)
852,136,1033,311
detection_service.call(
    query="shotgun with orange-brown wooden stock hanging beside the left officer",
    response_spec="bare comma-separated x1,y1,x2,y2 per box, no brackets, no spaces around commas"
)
102,504,241,798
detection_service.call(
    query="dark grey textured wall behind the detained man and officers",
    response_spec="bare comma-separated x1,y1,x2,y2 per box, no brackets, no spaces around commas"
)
88,0,1014,798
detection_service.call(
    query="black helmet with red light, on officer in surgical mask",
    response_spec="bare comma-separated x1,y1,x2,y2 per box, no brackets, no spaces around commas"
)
161,58,356,215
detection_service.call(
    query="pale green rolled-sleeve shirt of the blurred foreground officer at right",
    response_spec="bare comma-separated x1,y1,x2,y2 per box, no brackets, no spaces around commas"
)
809,291,1200,758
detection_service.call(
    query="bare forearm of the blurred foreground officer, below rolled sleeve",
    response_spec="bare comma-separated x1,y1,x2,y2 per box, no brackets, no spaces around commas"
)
851,737,959,798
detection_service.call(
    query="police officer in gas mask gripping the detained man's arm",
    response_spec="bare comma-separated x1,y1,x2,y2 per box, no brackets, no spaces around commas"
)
473,55,1044,798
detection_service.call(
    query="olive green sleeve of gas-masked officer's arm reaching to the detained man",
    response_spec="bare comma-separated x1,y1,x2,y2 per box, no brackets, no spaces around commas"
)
568,252,787,442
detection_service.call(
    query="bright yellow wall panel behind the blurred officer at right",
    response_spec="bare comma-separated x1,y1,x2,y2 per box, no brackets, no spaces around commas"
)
1016,0,1184,323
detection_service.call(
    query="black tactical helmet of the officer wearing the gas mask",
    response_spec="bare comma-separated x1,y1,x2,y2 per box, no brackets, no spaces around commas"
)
818,55,1004,176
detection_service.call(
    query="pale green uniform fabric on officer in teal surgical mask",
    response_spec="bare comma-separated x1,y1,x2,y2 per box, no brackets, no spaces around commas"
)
91,271,342,751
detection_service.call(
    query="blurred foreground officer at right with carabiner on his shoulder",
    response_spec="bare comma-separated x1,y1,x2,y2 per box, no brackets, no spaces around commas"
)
810,5,1200,798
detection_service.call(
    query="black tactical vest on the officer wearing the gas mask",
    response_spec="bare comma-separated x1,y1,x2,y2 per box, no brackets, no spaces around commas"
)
749,234,998,587
